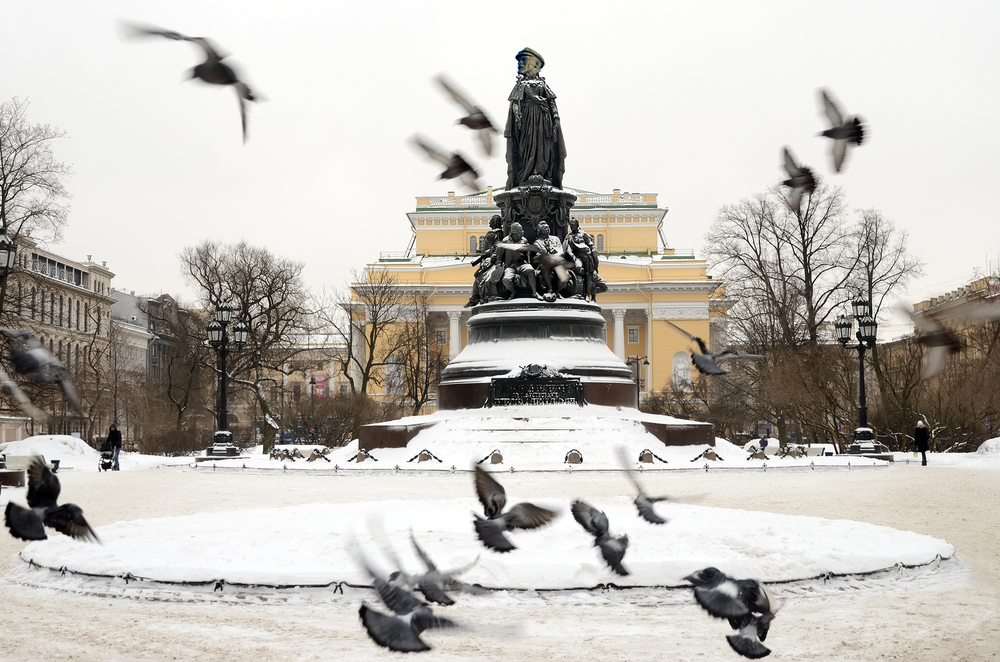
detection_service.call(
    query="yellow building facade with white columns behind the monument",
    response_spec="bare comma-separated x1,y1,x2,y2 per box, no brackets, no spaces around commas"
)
359,188,729,404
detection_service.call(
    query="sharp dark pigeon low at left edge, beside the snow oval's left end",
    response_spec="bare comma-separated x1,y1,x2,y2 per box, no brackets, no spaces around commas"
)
5,456,101,542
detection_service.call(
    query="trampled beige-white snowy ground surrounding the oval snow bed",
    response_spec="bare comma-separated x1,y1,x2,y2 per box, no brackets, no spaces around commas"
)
0,464,1000,662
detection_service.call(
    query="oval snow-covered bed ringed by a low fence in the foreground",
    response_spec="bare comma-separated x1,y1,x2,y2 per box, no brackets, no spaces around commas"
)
15,496,955,588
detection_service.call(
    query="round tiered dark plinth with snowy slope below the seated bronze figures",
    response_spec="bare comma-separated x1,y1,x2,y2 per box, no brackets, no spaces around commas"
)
438,299,637,409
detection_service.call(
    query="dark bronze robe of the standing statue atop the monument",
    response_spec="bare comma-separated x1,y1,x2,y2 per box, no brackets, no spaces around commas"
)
504,76,566,191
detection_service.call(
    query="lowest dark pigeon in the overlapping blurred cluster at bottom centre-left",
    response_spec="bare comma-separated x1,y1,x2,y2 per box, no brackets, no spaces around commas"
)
358,559,462,653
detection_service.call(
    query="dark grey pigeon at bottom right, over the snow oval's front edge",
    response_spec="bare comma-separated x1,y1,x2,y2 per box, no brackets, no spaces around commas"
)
684,567,779,660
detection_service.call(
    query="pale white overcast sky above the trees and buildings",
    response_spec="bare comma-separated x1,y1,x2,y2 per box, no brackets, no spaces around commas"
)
0,0,1000,338
